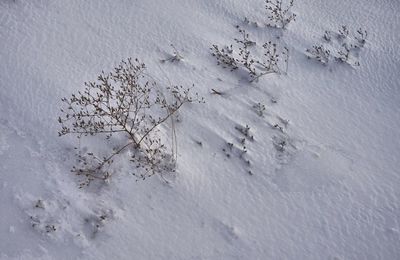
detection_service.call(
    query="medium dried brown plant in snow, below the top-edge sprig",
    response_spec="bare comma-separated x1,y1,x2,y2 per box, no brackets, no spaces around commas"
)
211,26,289,82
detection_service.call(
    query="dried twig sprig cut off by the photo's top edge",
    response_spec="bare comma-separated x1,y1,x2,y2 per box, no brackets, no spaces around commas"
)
265,0,296,29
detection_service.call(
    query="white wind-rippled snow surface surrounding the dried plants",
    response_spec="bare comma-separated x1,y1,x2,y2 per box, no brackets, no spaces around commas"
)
0,0,400,259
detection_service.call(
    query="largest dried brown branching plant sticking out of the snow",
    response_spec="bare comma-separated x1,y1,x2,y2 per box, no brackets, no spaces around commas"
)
58,59,203,187
